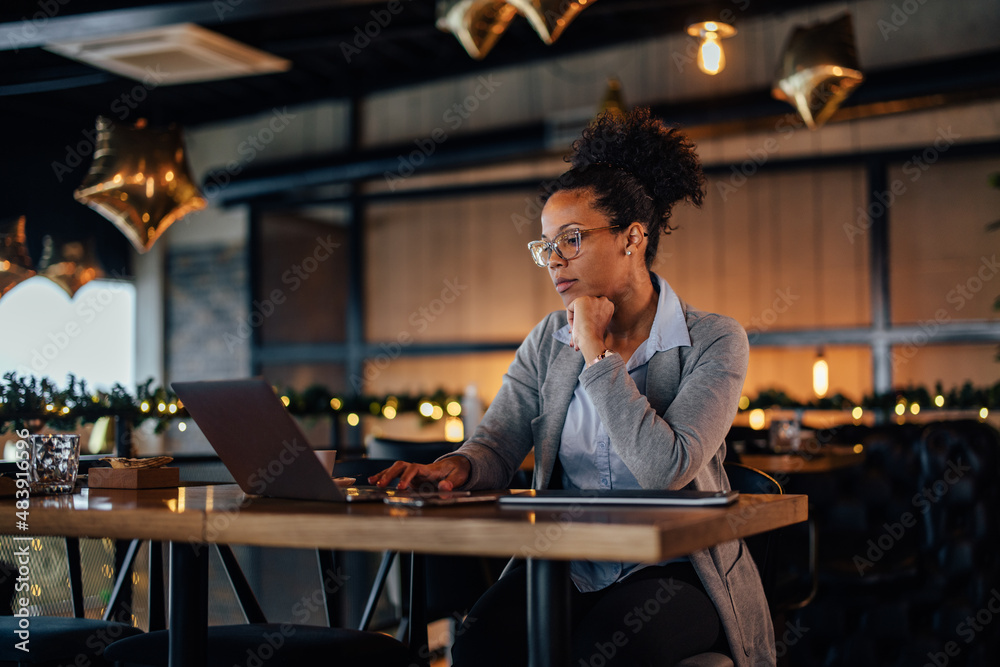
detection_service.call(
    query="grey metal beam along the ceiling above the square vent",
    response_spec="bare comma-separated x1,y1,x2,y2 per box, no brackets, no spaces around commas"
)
0,0,380,51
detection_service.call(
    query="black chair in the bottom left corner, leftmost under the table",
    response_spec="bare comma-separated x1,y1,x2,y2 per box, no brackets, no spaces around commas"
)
0,538,142,666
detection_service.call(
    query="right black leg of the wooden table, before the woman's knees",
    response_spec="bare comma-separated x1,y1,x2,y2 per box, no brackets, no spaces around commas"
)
528,558,571,667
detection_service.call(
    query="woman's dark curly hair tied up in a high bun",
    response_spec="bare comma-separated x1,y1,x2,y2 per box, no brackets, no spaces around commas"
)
549,107,705,268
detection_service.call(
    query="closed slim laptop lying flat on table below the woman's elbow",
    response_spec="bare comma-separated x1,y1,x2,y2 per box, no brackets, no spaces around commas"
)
500,489,740,507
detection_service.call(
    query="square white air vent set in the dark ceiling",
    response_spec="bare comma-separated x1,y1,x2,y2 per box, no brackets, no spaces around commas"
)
45,23,292,85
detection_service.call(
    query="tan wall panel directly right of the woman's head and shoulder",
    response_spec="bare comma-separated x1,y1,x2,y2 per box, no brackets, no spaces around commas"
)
668,167,871,332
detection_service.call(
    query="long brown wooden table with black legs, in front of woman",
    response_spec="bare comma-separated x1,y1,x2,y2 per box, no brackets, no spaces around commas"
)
0,485,807,667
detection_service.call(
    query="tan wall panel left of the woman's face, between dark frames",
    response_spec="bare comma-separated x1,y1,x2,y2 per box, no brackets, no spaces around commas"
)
366,194,562,342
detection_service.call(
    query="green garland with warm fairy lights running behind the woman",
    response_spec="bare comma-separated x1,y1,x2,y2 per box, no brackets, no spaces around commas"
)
0,372,1000,433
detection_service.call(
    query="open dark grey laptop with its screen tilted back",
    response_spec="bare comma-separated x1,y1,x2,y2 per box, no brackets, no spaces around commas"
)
170,378,391,502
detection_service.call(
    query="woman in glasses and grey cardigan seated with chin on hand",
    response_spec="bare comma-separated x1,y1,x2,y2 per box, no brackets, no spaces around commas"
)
370,109,775,667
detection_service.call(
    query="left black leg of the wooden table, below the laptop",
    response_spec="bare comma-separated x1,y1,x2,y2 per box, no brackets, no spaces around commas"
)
169,542,208,667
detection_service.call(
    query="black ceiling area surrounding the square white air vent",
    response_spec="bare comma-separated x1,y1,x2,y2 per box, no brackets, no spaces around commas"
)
0,0,844,125
